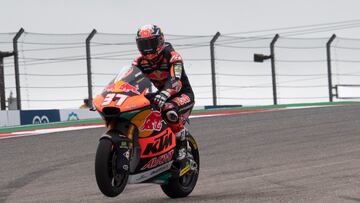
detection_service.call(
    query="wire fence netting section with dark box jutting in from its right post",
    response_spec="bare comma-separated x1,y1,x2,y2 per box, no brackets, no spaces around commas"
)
215,36,272,105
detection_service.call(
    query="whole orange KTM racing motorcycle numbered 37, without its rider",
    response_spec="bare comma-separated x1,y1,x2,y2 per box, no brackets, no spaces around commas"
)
93,67,200,198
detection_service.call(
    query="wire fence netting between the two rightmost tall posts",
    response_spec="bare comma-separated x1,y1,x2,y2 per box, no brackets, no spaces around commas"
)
275,37,329,104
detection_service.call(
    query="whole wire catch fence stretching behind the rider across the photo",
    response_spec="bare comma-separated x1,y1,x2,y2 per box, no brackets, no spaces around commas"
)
0,30,360,109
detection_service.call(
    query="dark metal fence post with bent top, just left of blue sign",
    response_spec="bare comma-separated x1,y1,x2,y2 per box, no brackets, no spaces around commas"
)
13,28,25,110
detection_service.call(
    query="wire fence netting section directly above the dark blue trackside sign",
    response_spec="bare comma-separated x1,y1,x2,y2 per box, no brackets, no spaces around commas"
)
5,32,88,109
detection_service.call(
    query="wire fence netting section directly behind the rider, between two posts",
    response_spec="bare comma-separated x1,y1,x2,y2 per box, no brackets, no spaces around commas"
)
91,33,212,105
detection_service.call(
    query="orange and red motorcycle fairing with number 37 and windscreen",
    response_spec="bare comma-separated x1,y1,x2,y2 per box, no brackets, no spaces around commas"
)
93,67,176,183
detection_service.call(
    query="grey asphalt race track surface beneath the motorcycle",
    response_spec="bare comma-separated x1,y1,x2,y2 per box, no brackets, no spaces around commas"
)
0,105,360,203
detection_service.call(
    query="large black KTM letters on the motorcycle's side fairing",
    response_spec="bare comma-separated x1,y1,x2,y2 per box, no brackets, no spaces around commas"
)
142,130,176,156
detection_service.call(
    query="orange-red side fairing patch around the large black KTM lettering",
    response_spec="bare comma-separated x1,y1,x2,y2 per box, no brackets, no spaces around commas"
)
139,128,176,158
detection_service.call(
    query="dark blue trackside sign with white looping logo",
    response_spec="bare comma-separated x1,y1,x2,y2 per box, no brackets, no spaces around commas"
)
20,110,60,125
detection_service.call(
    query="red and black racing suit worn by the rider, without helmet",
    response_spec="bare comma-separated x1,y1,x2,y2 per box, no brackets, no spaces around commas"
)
132,42,195,133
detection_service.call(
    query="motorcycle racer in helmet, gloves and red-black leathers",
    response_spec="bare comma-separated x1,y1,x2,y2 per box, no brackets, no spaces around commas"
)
132,25,194,163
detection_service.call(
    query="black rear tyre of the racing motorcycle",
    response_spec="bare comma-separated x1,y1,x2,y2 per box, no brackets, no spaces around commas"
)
161,135,200,198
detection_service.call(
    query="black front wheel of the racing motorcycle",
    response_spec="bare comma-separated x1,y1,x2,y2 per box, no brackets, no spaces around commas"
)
95,139,129,197
